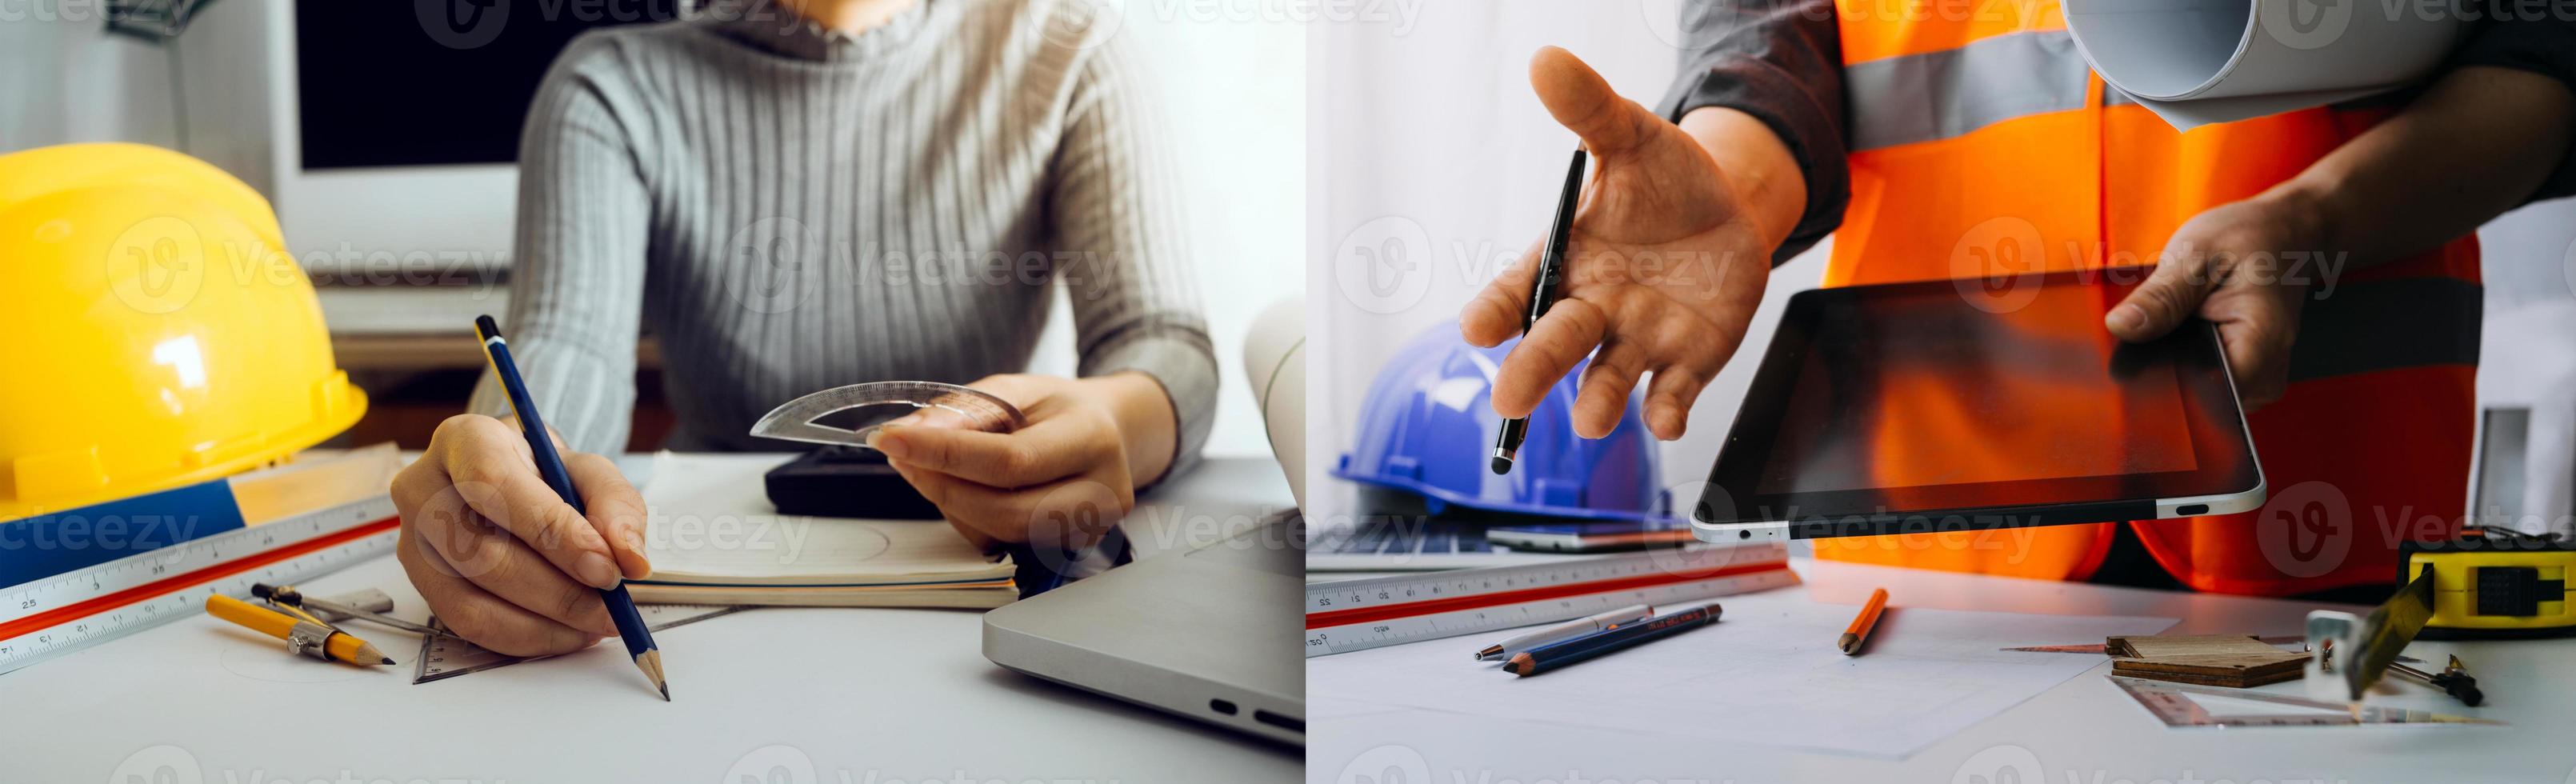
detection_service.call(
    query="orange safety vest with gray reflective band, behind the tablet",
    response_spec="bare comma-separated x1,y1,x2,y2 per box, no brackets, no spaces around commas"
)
1816,0,2481,596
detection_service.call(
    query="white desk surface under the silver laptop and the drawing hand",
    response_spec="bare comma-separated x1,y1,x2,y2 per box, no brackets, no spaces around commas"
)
0,459,1301,784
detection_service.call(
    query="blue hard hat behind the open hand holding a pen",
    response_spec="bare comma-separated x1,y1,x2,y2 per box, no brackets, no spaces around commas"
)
1332,322,1672,521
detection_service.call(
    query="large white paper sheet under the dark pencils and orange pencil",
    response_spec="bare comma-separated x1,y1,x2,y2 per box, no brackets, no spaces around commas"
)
1306,590,2174,758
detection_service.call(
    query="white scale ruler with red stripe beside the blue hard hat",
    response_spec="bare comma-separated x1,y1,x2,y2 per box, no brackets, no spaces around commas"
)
1306,544,1798,658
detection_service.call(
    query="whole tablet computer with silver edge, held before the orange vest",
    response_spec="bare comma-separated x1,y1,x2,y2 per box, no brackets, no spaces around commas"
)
1693,270,2264,542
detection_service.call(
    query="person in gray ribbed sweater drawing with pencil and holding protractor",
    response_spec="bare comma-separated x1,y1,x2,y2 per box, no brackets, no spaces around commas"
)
394,0,1216,655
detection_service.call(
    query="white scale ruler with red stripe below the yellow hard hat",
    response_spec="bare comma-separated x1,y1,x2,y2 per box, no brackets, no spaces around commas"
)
0,495,399,673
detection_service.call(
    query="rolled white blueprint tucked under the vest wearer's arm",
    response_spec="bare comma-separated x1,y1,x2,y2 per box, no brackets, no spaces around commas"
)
2063,0,2478,131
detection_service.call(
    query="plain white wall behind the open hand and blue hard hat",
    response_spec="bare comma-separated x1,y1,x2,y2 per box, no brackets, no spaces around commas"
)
1306,0,2576,521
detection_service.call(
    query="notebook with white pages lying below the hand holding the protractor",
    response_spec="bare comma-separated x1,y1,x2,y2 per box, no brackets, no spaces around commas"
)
626,451,1020,609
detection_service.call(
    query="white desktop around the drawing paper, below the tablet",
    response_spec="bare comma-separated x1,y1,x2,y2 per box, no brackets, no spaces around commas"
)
1306,560,2576,784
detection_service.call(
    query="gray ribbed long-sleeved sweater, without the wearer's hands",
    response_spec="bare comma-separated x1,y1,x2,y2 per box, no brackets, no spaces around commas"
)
471,0,1216,470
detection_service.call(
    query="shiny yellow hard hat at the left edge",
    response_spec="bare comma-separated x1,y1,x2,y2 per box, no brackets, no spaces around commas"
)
0,145,366,521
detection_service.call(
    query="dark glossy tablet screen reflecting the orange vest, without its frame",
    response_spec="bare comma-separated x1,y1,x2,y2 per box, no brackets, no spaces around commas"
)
1759,286,2194,493
